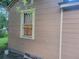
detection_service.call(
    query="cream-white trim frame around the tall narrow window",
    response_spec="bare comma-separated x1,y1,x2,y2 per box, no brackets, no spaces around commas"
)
20,9,35,40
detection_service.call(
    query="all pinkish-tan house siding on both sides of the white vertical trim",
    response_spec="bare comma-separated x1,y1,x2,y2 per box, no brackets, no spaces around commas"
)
9,0,79,59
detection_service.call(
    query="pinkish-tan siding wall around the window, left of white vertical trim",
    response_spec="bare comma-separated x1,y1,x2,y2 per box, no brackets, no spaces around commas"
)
9,0,60,59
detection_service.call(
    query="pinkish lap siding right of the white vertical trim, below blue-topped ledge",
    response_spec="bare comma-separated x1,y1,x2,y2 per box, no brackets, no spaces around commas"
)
62,10,79,59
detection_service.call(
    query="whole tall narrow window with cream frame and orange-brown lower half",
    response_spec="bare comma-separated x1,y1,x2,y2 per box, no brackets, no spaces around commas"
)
20,9,35,39
